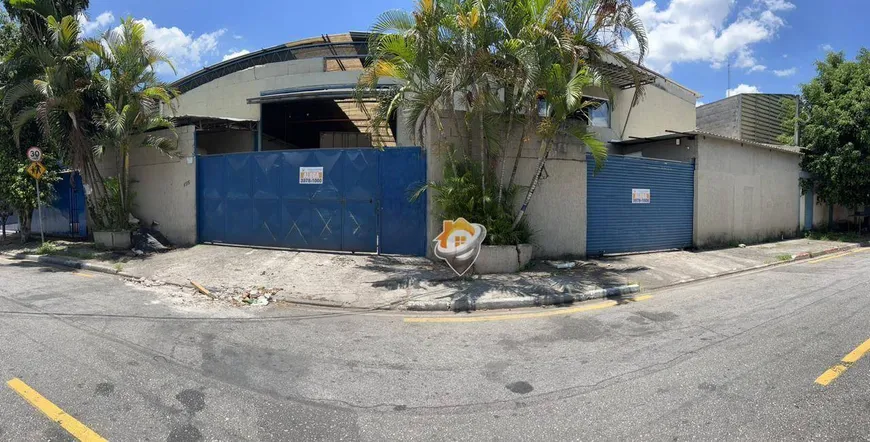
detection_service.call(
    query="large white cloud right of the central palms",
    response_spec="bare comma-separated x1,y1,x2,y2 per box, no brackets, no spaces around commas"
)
629,0,795,73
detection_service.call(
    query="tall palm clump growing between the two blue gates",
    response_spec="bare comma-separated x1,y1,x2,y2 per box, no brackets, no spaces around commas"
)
359,0,647,233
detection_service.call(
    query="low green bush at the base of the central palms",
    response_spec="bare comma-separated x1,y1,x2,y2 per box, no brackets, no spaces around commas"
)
414,152,532,245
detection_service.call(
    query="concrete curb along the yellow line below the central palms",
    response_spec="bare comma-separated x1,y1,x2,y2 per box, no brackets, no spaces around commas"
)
405,284,640,312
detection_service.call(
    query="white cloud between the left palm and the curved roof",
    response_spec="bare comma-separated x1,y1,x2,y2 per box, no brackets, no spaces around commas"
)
124,18,227,76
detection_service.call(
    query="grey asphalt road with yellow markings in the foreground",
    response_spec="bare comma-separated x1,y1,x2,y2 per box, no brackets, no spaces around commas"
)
0,249,870,441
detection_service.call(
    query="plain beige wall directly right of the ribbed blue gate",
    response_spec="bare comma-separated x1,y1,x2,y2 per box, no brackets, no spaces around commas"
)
695,136,801,247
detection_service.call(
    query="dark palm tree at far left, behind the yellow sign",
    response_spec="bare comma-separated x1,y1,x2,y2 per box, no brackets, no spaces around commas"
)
3,13,111,228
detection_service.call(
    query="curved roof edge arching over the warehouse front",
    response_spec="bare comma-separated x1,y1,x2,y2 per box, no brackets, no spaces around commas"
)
172,31,369,93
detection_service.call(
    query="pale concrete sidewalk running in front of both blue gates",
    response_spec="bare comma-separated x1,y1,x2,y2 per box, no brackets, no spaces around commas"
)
4,239,858,311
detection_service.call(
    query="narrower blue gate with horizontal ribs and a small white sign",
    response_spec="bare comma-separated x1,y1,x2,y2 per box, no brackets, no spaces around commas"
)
586,155,695,256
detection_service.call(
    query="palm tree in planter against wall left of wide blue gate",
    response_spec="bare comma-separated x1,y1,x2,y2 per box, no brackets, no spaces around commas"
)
84,17,178,224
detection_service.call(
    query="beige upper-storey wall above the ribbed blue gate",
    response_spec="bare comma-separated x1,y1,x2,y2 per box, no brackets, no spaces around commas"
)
611,78,697,140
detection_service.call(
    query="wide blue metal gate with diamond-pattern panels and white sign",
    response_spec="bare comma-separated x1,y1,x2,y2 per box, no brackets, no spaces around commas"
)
197,147,426,255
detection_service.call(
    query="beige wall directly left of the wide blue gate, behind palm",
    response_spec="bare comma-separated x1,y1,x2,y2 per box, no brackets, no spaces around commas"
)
99,126,196,245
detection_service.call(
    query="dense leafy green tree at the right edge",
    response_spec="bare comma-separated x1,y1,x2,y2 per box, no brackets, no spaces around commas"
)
790,49,870,209
